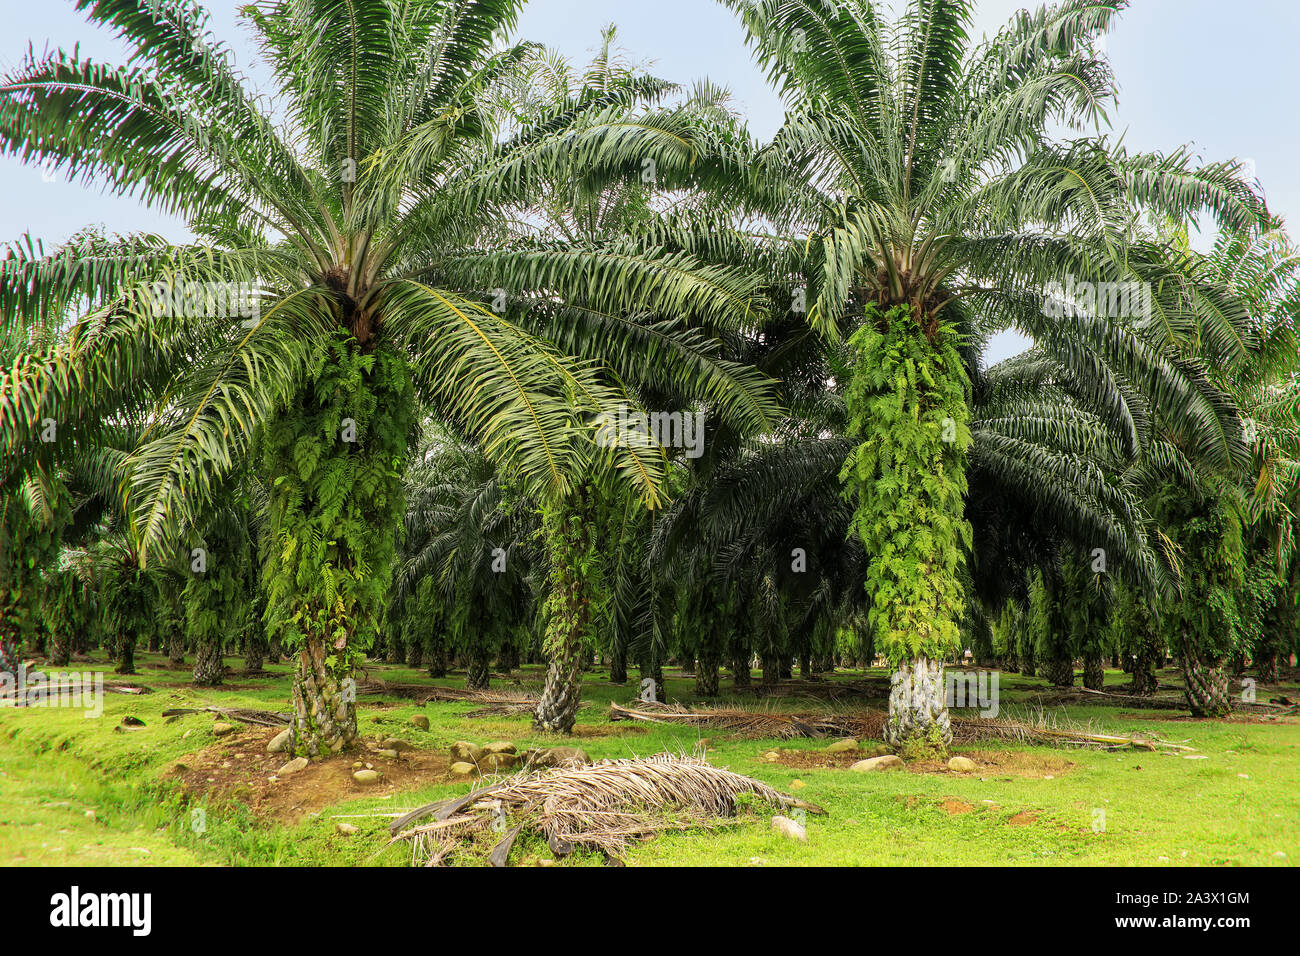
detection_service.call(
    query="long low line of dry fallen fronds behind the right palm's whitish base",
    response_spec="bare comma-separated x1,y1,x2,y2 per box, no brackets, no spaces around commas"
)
610,704,1192,750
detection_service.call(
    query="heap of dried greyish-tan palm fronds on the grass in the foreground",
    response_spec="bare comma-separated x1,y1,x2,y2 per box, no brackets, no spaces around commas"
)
379,753,823,866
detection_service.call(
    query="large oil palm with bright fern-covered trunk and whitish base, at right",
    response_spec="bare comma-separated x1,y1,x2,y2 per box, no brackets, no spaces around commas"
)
727,0,1262,749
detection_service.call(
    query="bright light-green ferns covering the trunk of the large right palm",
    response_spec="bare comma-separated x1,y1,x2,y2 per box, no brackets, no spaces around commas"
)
841,306,971,665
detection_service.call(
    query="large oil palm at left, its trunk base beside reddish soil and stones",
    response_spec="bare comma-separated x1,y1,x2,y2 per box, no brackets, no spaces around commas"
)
0,0,750,753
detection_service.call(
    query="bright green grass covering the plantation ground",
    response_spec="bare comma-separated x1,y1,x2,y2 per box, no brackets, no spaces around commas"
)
0,654,1300,866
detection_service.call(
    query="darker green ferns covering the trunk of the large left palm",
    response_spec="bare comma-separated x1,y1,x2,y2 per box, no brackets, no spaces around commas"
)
263,332,413,678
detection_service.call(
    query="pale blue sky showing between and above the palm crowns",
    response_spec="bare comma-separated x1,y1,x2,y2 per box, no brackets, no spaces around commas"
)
0,0,1300,360
